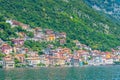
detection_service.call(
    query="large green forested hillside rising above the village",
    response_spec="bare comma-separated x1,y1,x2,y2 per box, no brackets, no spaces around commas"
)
0,0,120,50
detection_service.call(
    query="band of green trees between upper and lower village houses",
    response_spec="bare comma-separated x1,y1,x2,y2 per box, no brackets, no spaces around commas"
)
24,40,75,54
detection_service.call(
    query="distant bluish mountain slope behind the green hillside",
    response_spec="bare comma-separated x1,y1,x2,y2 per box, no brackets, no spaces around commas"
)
85,0,120,20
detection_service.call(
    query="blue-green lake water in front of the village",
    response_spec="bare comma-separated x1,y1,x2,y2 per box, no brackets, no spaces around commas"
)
0,65,120,80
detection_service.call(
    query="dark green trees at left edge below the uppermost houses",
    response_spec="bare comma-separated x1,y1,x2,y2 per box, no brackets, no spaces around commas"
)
0,15,33,41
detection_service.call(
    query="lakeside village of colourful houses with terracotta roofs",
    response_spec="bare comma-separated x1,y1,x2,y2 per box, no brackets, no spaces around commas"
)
0,20,120,68
